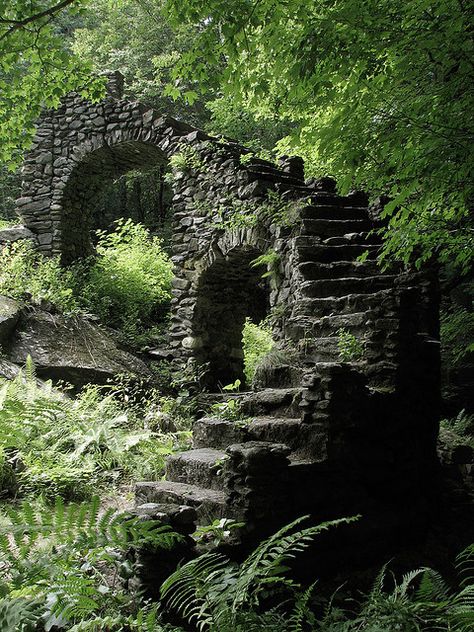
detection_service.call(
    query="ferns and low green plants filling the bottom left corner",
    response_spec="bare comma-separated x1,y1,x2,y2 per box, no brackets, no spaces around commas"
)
0,497,180,632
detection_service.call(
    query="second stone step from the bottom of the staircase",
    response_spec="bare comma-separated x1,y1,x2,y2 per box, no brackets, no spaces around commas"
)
166,447,225,490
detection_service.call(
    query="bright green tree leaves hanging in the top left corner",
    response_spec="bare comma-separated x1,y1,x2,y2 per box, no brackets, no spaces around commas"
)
0,0,103,166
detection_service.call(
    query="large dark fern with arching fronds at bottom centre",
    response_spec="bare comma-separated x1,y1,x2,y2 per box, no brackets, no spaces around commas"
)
161,518,355,632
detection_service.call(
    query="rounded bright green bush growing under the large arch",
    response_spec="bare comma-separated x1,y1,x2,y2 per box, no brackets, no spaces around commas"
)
76,219,173,340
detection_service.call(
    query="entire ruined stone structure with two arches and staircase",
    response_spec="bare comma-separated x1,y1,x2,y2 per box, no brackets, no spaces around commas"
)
18,75,439,548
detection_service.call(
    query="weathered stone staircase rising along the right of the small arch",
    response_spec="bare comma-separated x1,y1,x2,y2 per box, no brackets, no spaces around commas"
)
136,185,436,537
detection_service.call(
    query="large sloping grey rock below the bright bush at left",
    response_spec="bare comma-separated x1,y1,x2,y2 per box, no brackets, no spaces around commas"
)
7,310,149,388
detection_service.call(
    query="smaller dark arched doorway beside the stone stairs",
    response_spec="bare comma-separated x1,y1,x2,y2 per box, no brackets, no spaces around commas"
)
193,246,270,390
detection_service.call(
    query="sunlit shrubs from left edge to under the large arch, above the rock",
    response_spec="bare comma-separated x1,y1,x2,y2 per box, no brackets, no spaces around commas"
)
0,220,173,346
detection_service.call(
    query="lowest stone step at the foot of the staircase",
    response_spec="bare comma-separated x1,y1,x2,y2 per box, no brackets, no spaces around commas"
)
135,481,226,524
